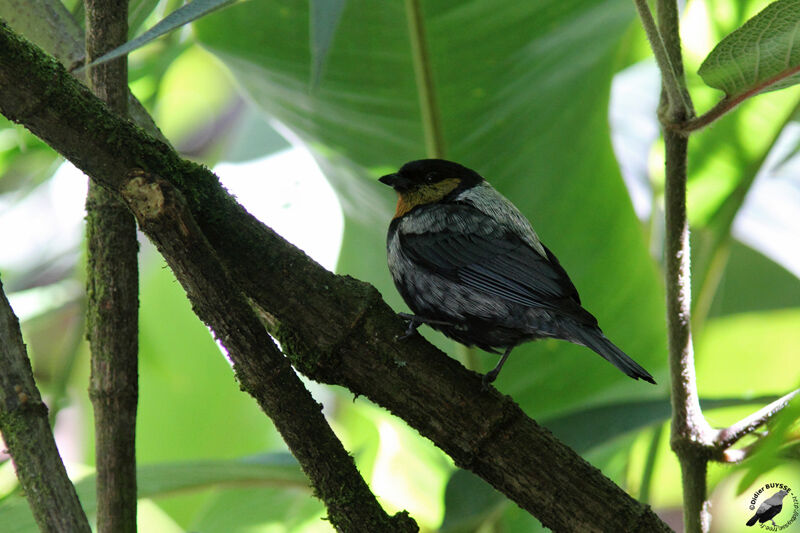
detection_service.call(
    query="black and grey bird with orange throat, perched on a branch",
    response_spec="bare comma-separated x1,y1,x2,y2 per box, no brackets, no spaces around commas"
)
379,159,656,390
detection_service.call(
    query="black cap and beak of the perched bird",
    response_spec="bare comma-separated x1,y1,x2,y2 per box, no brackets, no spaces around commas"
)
380,159,483,194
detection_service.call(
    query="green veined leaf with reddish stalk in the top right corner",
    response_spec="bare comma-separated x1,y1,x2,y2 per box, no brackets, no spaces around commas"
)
698,0,800,100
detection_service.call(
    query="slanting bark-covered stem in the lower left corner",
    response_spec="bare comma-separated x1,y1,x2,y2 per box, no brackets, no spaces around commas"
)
0,276,91,533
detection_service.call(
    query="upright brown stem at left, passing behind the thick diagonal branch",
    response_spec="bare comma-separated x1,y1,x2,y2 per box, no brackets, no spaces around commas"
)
85,0,139,533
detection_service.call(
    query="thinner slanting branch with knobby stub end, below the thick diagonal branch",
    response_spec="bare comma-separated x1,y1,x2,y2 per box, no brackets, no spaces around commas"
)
122,172,418,532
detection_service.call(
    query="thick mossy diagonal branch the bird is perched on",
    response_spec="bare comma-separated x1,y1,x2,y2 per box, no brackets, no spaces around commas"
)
0,22,669,532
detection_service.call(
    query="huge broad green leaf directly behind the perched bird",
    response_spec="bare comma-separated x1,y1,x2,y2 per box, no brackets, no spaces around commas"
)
195,0,666,424
